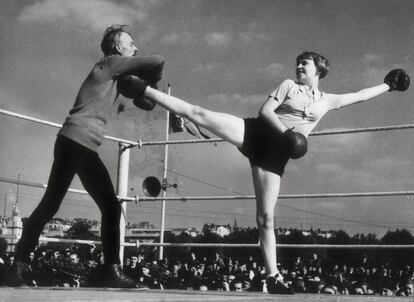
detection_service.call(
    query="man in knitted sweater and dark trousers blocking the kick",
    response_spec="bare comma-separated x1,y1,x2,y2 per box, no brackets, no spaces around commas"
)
6,26,164,288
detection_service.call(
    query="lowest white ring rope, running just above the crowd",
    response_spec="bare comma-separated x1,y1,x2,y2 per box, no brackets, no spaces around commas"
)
0,235,414,249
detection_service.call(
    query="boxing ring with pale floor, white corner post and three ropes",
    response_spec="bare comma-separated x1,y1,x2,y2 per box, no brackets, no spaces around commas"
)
0,108,414,301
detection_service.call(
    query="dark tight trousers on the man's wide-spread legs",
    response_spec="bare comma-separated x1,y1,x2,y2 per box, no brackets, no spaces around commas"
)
15,136,121,264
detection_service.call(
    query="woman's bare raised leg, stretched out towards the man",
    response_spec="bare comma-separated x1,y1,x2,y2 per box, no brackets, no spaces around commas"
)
144,87,244,147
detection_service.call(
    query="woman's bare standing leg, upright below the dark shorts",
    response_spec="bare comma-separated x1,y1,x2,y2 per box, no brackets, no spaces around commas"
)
252,166,281,276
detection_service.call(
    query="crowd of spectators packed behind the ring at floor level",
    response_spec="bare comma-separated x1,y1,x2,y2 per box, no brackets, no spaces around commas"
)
0,246,414,296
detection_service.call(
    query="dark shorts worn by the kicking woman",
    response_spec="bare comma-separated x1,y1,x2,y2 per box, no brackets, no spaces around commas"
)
239,117,289,176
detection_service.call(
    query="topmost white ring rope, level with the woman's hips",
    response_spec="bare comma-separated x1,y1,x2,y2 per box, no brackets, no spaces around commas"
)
0,108,414,148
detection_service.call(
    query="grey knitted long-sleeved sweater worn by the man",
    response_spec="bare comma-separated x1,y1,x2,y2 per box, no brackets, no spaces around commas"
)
58,55,164,152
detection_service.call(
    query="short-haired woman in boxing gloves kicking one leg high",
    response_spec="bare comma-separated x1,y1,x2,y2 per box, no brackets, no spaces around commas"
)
121,52,409,293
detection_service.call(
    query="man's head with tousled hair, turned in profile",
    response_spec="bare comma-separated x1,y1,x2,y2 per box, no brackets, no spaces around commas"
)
101,25,138,56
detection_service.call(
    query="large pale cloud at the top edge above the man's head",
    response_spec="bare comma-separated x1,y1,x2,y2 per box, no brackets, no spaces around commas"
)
18,0,148,32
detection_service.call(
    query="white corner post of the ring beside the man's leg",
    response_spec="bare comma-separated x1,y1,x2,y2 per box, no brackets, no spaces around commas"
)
117,143,130,265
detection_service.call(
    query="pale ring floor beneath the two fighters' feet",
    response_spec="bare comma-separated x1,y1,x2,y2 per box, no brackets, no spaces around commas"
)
0,287,414,302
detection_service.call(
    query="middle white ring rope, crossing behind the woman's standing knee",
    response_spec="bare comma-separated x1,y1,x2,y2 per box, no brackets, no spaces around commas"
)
0,176,414,203
